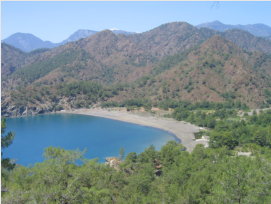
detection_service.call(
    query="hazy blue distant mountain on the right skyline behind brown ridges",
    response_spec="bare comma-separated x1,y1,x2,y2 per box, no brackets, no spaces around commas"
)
196,21,271,37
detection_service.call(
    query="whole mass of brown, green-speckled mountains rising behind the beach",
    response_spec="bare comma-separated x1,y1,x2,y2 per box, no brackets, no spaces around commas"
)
1,22,271,115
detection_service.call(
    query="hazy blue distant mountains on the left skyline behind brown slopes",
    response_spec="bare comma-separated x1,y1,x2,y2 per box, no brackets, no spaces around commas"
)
1,28,136,52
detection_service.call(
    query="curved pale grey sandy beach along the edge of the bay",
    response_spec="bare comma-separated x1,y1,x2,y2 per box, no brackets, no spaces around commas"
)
59,108,208,152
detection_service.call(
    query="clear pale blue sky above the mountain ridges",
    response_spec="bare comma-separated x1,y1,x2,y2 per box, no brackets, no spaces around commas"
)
1,1,271,43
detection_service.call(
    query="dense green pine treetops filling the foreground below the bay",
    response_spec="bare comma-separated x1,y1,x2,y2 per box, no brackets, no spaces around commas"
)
2,141,271,203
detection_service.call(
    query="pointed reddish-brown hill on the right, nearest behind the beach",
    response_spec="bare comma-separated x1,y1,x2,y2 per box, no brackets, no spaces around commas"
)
114,35,271,107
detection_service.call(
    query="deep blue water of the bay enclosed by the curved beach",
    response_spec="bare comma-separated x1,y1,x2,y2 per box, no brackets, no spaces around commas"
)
2,114,180,166
